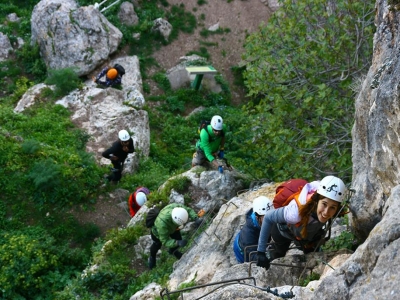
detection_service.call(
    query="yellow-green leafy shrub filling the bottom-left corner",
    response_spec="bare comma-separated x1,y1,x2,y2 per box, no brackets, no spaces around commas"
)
0,227,85,299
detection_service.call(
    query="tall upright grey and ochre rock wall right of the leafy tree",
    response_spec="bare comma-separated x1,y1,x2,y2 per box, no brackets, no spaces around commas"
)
351,1,400,238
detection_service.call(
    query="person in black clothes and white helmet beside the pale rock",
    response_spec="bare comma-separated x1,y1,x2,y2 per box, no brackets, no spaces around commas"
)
102,130,135,183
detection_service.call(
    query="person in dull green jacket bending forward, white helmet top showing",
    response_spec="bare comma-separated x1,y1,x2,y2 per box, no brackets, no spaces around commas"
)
149,203,202,269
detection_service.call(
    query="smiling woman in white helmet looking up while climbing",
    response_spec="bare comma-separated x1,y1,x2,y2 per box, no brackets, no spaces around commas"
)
257,176,347,269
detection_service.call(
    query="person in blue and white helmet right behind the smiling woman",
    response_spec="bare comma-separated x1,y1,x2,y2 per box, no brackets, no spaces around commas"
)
233,196,274,263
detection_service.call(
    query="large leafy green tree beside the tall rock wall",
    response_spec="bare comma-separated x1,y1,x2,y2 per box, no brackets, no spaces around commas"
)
238,0,374,180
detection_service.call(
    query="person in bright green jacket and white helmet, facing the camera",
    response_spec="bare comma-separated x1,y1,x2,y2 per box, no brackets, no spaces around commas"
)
192,116,226,168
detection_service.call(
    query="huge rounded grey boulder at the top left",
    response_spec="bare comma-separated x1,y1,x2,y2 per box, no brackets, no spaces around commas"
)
31,0,122,75
